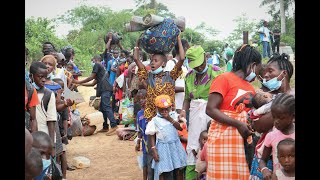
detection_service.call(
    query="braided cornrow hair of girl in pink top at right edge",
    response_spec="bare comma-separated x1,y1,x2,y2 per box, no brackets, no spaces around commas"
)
271,93,296,114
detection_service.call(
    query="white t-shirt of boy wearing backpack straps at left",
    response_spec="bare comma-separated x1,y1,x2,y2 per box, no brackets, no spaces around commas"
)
36,92,57,142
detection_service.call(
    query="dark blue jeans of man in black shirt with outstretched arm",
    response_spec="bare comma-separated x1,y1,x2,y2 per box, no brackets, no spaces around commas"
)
99,91,117,129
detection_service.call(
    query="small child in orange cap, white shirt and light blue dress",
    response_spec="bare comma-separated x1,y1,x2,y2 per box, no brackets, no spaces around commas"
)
146,95,187,180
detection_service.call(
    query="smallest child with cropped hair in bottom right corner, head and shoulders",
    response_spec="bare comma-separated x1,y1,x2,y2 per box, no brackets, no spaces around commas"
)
272,138,296,180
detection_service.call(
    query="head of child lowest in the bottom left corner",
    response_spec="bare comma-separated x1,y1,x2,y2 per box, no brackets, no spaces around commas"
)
24,148,43,180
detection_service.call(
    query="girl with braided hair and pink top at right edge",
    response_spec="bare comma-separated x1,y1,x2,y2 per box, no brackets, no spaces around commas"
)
259,94,295,179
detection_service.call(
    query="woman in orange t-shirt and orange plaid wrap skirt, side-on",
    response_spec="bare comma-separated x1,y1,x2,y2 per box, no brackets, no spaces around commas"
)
206,44,261,180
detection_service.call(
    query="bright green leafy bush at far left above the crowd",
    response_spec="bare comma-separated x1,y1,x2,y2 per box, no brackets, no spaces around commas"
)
25,17,67,64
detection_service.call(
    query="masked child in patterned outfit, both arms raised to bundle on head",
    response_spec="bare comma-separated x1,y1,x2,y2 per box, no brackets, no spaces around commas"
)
133,36,185,121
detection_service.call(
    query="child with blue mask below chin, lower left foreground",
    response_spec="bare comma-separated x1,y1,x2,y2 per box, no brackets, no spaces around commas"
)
31,131,53,180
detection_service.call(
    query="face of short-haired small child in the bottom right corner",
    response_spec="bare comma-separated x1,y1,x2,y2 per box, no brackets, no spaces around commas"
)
278,144,296,171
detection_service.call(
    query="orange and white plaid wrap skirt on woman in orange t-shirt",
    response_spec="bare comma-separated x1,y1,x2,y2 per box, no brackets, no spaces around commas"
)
207,106,252,180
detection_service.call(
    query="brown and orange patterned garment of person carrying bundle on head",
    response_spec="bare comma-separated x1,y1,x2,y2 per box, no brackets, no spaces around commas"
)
138,66,182,121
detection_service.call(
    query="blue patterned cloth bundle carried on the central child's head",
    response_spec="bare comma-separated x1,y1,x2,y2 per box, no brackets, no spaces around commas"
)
139,18,180,54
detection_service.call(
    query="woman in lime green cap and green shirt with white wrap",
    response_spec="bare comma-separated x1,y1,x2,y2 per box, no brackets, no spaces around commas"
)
179,46,222,180
